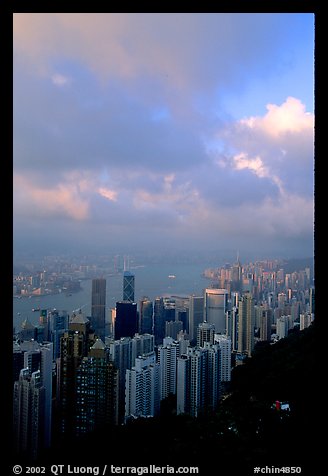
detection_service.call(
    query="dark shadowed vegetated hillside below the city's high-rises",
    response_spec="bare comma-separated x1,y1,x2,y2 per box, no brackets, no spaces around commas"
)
39,324,320,476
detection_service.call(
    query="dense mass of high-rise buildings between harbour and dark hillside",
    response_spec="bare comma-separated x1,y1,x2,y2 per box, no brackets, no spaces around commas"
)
13,259,315,460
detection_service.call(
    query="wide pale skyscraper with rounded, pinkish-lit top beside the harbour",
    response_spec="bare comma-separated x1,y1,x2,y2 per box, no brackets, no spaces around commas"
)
204,289,228,334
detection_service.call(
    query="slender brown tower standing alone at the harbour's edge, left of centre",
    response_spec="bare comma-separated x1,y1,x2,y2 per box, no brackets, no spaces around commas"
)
91,278,106,340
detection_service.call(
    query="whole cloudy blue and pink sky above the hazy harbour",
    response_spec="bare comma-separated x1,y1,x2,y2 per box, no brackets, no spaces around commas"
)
13,13,314,258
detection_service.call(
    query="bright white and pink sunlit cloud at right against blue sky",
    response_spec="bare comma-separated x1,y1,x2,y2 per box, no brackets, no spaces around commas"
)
211,97,314,197
